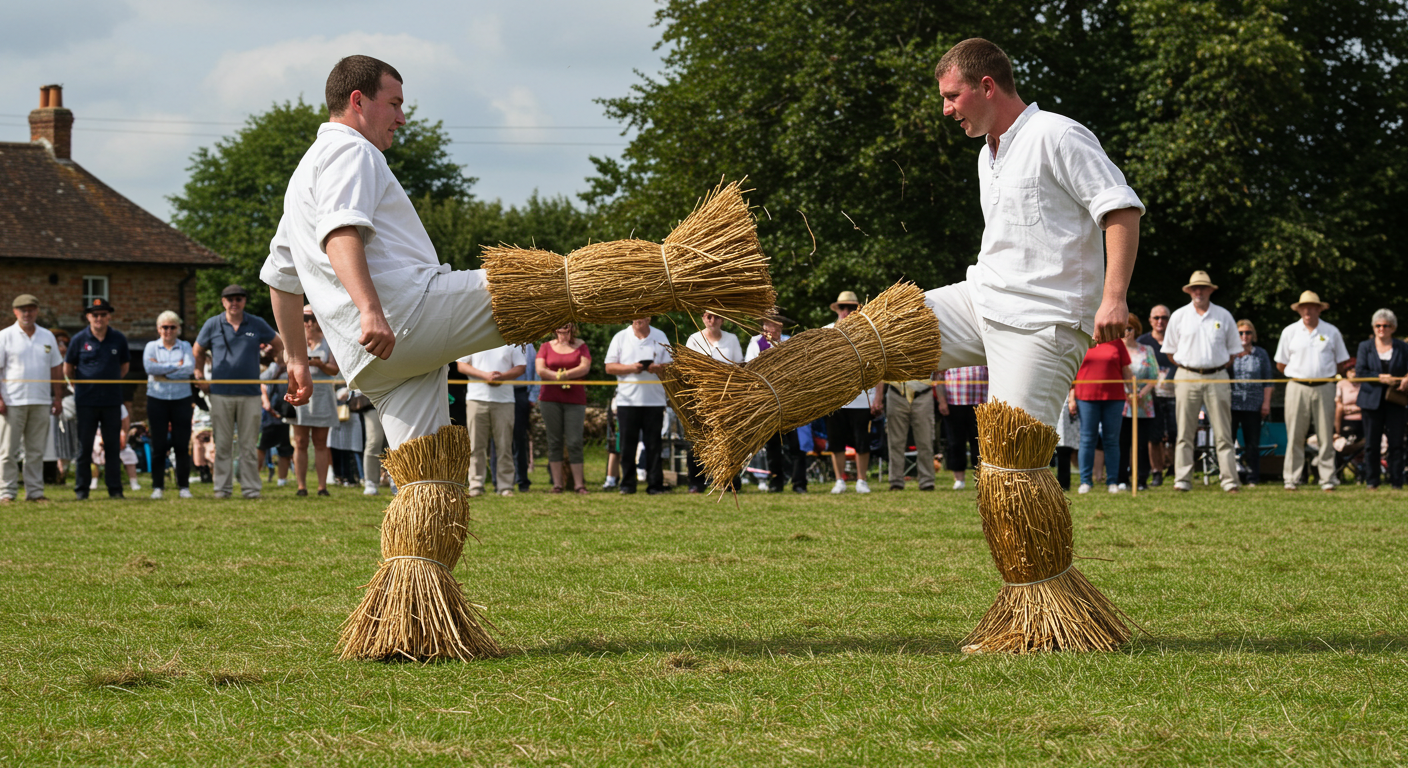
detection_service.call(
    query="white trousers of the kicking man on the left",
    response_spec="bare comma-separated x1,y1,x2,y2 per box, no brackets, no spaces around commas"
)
351,269,504,448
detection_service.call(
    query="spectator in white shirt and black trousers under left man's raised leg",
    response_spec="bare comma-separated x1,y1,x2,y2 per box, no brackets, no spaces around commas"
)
605,317,673,496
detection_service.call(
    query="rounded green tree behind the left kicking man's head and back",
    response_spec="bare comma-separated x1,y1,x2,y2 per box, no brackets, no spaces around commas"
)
169,99,474,317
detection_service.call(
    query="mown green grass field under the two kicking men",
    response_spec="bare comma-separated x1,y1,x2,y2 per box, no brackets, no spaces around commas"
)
0,450,1408,767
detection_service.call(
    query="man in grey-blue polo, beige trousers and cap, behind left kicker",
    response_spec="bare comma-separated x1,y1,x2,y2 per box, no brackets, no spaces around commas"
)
193,285,283,499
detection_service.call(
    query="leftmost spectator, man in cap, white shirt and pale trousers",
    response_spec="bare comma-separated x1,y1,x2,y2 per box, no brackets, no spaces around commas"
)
0,293,63,504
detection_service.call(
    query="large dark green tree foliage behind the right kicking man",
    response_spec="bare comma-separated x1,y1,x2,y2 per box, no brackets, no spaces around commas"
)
584,0,1408,335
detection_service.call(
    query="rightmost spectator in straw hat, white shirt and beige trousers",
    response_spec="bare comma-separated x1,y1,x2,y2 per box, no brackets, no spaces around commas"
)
1274,290,1354,490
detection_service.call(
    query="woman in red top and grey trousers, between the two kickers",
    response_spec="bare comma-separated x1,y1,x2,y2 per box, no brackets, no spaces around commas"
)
538,323,591,493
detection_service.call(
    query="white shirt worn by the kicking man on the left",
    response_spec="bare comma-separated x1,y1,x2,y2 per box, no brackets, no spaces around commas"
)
259,123,451,379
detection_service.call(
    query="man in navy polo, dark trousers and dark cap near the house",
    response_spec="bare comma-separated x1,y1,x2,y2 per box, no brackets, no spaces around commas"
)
63,299,130,500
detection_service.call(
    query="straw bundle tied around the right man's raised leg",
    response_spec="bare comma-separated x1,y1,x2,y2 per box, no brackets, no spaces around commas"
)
662,282,942,488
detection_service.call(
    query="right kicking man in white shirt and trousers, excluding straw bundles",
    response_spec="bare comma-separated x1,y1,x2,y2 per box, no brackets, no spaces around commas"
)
926,38,1143,424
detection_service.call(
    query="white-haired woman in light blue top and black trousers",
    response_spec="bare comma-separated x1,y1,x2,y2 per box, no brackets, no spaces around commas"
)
142,310,196,499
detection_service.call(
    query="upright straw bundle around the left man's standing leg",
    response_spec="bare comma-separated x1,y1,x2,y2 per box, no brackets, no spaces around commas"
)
339,427,501,661
